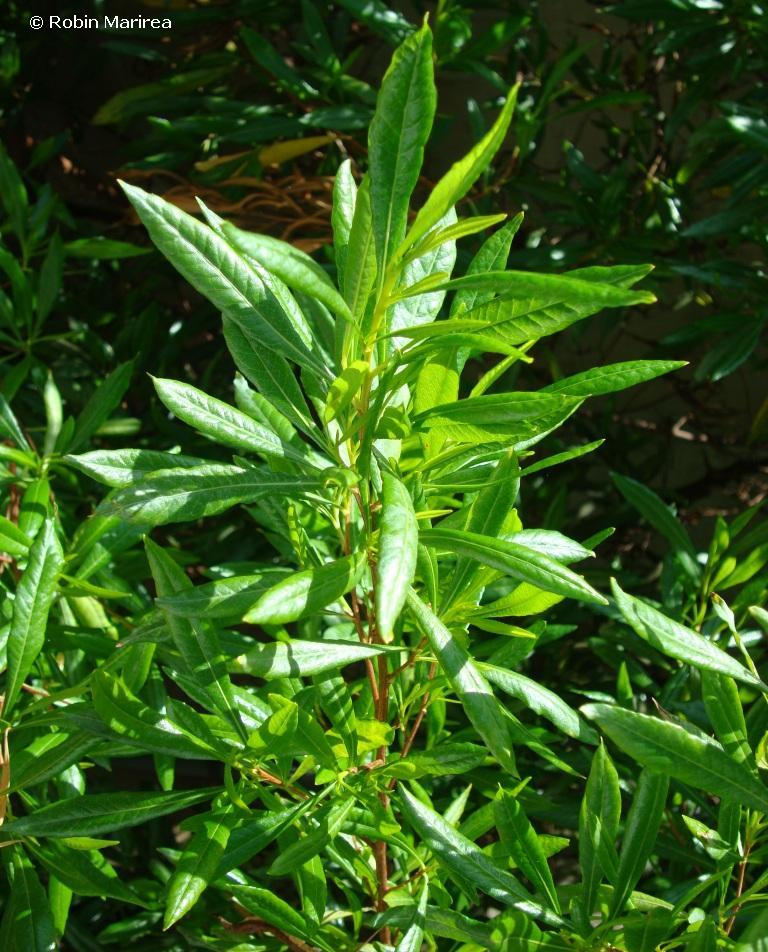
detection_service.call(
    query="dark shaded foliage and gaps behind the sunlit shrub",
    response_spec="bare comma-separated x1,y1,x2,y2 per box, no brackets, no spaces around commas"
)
0,0,768,941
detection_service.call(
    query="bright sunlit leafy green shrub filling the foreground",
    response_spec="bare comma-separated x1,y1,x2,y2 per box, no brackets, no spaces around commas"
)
0,16,768,952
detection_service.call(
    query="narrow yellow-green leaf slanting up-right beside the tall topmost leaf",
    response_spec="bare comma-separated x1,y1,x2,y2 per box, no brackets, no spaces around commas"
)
397,86,518,254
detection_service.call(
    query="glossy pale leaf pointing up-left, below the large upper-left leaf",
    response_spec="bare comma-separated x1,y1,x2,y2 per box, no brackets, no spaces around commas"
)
153,378,316,463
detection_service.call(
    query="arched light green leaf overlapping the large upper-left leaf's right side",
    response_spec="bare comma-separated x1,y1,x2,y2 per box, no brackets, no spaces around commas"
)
222,223,352,319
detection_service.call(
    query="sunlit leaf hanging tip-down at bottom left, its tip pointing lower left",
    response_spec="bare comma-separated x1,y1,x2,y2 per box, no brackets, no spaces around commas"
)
163,805,241,929
